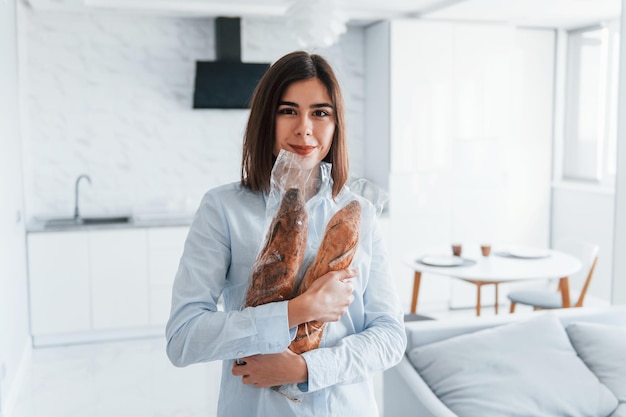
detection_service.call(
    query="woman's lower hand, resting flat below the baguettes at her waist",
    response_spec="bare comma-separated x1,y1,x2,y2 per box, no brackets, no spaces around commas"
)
232,349,308,388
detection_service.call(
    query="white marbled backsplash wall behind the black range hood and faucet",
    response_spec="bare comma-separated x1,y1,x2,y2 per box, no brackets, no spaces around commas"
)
20,8,364,218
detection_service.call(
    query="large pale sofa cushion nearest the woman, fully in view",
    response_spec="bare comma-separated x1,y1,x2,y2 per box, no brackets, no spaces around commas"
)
408,313,617,417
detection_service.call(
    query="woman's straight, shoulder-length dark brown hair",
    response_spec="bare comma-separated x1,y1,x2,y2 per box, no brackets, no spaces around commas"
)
241,51,348,198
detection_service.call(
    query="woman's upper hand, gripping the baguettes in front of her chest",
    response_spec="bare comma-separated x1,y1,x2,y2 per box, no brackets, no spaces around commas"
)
288,269,357,327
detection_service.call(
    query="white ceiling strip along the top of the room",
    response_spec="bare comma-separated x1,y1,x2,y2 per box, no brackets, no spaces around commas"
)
24,0,621,28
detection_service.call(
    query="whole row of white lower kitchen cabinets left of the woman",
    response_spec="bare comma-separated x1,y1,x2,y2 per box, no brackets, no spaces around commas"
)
28,226,189,346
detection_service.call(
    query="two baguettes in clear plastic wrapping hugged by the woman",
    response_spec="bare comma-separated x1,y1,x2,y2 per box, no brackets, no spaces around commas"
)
244,150,386,354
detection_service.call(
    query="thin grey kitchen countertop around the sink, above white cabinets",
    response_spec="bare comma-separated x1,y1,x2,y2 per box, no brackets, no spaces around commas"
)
26,215,193,233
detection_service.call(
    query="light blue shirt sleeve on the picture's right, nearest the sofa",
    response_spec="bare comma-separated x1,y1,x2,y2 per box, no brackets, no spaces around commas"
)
282,214,406,397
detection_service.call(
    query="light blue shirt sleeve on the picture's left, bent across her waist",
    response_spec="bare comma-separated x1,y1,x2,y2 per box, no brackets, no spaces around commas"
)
166,193,295,366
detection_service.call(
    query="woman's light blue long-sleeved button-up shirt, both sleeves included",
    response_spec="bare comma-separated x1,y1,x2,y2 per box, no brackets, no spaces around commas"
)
166,167,406,417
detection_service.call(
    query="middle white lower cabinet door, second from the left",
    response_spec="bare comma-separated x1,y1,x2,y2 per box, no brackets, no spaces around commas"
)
89,229,149,330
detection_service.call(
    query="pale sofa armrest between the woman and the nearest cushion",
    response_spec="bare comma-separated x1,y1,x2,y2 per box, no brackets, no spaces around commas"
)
383,356,458,417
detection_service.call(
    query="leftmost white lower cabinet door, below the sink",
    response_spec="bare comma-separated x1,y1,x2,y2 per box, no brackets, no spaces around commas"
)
28,232,91,335
